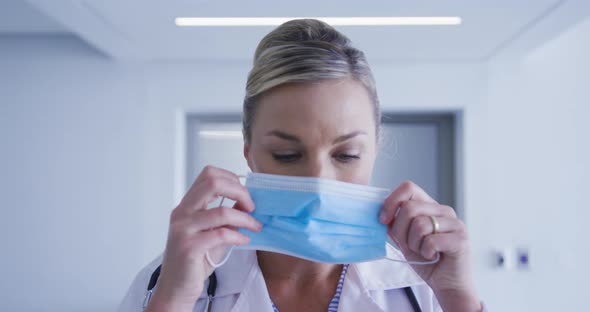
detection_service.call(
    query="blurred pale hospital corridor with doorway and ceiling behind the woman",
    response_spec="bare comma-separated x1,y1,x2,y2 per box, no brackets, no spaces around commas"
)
0,0,590,311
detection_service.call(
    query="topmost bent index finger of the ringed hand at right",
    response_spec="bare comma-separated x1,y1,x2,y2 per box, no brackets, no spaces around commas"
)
379,181,437,224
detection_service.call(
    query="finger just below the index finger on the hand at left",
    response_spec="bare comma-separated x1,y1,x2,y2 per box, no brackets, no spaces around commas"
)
187,207,262,232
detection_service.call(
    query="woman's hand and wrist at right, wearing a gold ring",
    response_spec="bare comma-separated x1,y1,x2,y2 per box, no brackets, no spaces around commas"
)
380,181,481,311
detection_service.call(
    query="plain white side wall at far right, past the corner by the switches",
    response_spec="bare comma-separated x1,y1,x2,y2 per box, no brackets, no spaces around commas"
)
477,18,590,311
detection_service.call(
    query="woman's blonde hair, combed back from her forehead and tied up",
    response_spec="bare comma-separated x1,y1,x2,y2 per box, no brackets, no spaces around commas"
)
242,19,381,143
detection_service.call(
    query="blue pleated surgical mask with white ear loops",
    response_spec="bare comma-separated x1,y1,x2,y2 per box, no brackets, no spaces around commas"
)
207,173,438,267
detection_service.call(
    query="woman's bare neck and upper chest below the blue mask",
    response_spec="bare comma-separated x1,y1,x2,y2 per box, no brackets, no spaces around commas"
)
256,251,342,285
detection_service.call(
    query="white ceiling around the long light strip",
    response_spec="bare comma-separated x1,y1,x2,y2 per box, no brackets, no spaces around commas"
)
0,0,590,62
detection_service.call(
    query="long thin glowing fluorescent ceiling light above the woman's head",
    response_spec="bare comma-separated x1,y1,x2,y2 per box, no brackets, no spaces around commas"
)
175,16,461,26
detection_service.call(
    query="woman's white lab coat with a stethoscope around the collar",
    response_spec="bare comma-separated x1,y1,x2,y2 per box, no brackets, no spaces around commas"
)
119,246,442,312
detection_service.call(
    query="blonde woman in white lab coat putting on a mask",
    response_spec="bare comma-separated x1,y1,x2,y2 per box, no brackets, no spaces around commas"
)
120,19,483,312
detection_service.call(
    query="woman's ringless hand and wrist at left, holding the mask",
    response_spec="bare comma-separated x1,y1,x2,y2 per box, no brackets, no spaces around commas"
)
147,166,262,311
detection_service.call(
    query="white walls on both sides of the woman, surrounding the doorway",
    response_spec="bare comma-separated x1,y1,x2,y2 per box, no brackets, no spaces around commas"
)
9,18,590,311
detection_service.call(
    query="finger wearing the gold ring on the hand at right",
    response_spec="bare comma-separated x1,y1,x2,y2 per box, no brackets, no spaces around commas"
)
408,216,464,253
